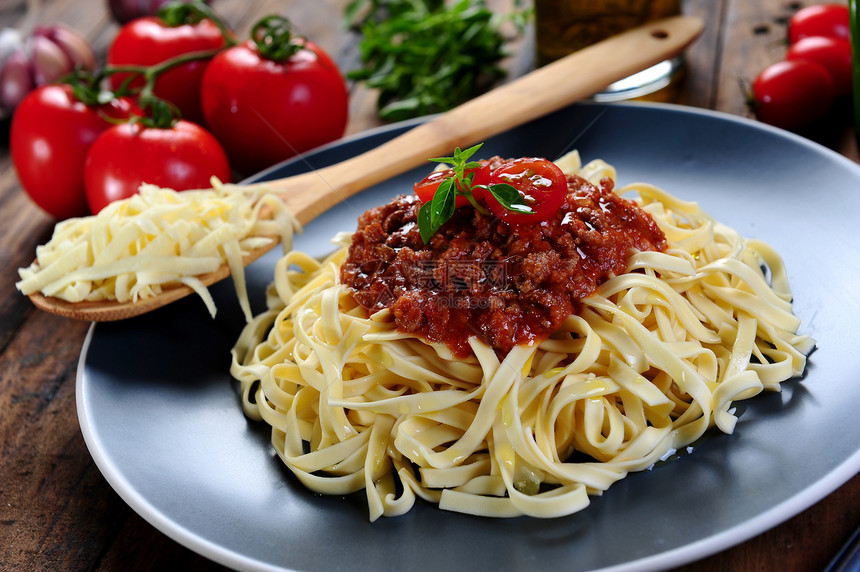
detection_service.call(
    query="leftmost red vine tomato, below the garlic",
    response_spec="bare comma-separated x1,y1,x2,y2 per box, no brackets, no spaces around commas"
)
9,85,139,220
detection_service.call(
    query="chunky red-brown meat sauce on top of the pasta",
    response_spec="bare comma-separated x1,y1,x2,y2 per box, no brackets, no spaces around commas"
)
341,168,666,357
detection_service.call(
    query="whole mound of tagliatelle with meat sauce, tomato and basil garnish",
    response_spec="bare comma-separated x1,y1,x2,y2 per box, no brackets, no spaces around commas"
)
230,150,815,521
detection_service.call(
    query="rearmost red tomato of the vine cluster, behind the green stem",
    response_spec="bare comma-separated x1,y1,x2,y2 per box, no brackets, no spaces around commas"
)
107,16,224,123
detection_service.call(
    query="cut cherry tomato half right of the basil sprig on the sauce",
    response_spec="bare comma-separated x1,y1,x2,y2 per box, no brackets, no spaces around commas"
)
486,157,567,225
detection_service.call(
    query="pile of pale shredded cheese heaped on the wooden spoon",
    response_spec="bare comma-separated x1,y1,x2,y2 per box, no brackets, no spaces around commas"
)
15,178,298,321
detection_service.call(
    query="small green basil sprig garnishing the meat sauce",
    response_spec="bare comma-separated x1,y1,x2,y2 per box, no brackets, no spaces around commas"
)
418,143,534,244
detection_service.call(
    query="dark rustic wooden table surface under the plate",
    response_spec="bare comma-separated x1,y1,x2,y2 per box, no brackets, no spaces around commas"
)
0,0,860,572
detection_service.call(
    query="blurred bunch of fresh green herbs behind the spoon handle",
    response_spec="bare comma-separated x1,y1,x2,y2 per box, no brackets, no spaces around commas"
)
345,0,530,121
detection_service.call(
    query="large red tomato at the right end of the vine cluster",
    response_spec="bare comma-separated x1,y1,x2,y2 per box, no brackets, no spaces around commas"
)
203,41,349,174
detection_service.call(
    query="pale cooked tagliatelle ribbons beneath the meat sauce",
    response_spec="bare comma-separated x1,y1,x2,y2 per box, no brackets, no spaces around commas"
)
231,156,814,520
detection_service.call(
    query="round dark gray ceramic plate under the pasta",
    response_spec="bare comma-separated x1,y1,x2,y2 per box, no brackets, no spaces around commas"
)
77,104,860,570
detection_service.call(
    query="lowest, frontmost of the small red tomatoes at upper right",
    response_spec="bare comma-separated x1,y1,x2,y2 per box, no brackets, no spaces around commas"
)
752,60,834,130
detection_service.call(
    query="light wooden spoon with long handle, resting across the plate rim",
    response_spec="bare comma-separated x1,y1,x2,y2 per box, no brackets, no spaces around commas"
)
30,16,704,322
